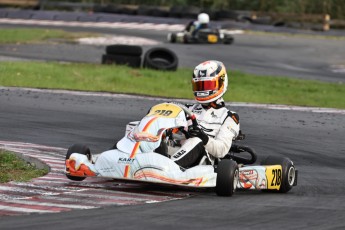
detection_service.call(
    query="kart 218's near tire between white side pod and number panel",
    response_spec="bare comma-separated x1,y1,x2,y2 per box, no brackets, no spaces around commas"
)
216,159,239,196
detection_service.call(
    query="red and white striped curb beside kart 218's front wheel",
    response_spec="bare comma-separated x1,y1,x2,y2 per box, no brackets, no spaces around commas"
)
0,141,191,216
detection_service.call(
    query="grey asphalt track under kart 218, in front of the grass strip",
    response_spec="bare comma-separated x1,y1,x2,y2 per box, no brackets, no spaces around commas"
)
0,11,345,229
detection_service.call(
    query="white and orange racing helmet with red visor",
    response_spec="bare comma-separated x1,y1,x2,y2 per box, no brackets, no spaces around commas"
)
192,60,228,104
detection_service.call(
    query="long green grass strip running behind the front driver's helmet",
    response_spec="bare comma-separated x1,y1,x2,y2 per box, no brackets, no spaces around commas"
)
0,62,345,109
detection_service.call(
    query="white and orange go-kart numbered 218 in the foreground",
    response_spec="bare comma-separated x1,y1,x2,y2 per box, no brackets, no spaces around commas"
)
65,103,297,196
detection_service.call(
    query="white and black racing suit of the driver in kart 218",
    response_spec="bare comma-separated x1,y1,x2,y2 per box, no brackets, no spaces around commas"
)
170,99,240,168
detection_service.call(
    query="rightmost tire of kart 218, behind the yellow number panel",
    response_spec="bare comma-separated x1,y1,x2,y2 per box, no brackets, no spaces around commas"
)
261,156,297,193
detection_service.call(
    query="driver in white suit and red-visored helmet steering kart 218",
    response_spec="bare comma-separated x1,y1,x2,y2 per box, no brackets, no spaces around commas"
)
169,60,240,168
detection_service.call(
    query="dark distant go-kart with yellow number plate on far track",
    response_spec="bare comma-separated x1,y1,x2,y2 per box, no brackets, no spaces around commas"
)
167,28,234,44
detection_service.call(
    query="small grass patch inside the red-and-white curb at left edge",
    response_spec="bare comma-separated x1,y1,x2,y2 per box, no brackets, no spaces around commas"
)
0,150,48,183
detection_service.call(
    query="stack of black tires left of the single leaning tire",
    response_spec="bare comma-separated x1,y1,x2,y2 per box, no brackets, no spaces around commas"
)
102,45,143,68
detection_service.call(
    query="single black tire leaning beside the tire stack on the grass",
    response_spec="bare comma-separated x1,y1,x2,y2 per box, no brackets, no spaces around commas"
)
143,47,178,71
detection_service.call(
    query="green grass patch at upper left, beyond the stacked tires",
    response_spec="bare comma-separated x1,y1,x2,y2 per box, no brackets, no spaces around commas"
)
0,28,97,44
